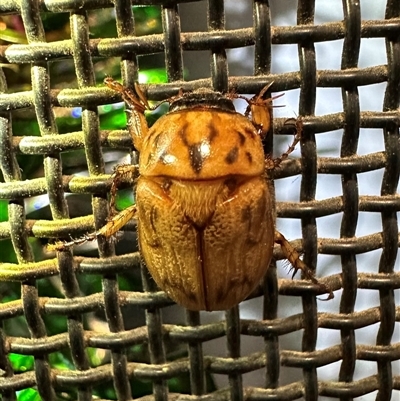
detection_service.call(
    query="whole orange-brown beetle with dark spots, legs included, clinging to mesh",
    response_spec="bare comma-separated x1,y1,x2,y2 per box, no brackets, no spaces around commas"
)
52,77,332,311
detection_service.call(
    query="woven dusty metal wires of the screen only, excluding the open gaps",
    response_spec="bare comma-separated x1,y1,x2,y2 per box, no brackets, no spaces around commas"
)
0,0,400,400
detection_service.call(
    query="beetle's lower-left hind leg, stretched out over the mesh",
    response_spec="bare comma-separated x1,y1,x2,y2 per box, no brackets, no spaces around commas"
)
47,205,137,251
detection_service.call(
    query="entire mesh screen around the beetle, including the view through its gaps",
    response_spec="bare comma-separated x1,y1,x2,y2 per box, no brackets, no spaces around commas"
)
0,0,400,400
